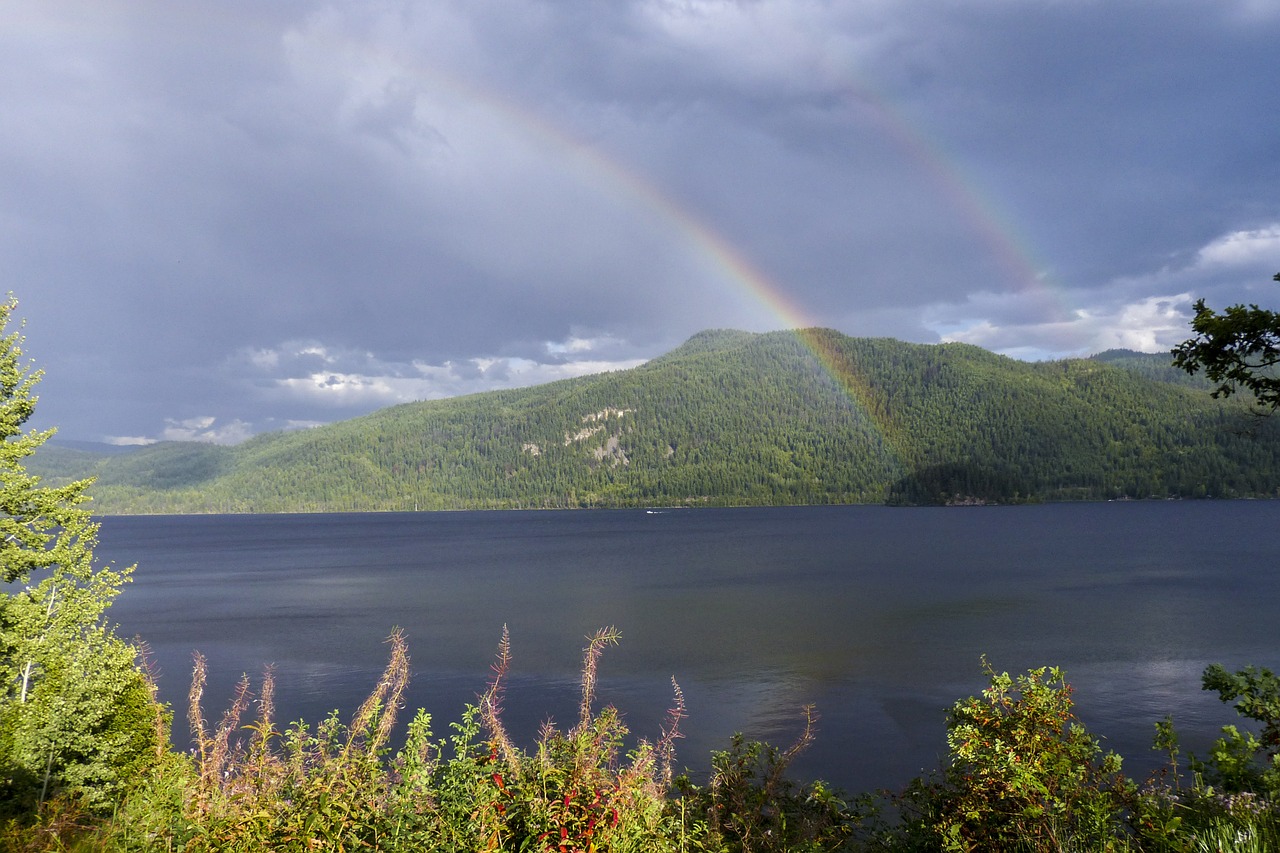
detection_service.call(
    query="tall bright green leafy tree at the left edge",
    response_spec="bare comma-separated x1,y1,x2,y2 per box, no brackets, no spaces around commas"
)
0,296,166,813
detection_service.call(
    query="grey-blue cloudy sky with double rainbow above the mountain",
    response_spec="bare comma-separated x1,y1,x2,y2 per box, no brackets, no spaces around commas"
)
0,0,1280,443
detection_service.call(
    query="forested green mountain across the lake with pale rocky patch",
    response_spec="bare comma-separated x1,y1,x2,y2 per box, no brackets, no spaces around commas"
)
31,329,1280,514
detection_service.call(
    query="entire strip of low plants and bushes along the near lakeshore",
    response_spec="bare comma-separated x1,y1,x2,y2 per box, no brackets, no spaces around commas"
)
0,629,1280,853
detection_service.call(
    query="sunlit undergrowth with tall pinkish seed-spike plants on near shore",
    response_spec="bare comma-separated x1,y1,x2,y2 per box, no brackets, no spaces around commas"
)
0,629,851,853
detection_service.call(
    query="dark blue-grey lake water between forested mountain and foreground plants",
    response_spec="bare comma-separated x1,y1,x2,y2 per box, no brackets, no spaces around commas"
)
97,501,1280,792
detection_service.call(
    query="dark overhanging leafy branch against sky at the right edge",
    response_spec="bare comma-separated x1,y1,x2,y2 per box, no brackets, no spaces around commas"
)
1174,267,1280,411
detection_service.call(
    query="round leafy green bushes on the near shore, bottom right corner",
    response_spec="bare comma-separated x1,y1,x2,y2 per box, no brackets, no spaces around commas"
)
868,662,1280,853
